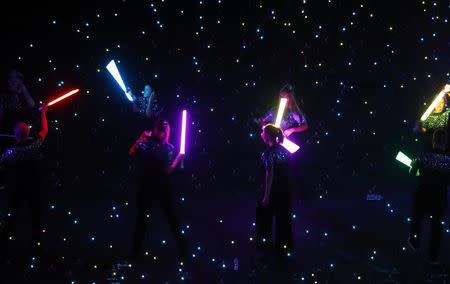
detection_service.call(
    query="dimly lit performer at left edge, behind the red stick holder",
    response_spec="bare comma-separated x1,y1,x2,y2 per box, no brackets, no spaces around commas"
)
0,70,35,133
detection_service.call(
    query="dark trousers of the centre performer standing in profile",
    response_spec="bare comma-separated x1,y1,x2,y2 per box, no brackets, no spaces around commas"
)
256,192,293,256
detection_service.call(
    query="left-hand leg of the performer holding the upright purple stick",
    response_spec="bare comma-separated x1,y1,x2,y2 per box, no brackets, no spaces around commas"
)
131,188,152,257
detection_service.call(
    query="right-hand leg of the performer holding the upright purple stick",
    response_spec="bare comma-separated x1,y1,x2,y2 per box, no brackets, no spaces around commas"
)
160,188,187,259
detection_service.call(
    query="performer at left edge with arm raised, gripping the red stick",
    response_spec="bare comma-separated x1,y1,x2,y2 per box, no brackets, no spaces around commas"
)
0,105,48,253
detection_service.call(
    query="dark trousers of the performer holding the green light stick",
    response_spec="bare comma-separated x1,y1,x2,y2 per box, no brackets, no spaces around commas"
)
410,192,445,261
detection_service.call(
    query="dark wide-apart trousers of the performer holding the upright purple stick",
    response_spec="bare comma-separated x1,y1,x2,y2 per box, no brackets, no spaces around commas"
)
132,188,186,257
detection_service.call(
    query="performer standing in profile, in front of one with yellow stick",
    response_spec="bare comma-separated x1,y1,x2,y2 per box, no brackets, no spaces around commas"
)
256,124,292,263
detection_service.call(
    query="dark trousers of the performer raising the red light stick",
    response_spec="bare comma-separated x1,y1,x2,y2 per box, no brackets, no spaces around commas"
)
0,186,41,253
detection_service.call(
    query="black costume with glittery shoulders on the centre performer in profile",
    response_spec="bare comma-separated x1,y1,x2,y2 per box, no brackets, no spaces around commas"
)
256,144,292,255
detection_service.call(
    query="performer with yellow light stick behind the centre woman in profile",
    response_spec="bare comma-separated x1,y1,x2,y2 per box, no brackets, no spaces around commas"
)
259,84,308,137
